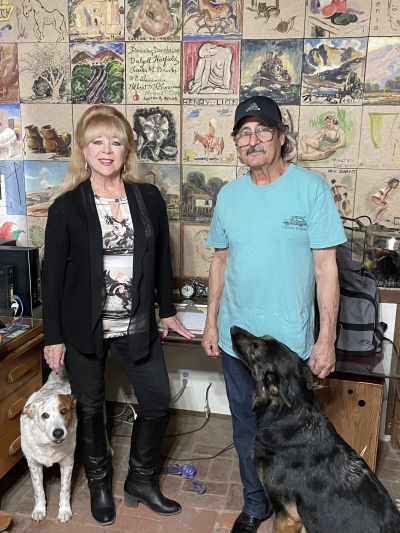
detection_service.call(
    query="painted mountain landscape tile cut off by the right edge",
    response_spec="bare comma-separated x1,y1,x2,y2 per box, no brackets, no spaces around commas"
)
364,37,400,104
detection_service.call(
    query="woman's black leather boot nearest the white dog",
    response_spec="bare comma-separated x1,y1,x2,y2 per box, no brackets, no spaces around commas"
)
77,407,115,526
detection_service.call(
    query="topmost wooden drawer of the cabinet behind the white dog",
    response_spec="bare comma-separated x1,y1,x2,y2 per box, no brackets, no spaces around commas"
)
0,343,43,403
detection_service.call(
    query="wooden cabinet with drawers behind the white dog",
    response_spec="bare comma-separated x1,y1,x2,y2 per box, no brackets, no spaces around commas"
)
0,319,43,478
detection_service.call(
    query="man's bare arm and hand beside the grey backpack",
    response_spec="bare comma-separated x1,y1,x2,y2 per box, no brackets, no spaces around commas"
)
308,246,340,378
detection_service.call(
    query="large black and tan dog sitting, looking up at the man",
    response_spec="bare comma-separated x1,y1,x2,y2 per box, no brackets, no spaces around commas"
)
231,326,400,533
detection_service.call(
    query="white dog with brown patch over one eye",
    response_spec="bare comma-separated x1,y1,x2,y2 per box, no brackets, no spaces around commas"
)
21,367,77,522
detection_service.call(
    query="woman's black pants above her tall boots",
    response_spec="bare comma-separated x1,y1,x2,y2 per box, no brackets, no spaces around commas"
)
65,337,170,418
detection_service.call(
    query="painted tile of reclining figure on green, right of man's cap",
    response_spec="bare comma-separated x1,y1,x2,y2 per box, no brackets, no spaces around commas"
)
297,106,362,168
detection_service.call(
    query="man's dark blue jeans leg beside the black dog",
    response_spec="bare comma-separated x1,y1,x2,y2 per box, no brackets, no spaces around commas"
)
220,349,272,520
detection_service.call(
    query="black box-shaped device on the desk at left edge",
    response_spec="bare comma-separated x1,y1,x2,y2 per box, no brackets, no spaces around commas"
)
0,246,42,316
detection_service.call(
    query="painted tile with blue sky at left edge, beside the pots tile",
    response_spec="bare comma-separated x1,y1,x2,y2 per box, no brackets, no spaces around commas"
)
0,103,22,160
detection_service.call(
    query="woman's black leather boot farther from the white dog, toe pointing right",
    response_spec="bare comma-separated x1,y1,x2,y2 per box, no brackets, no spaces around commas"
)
124,414,182,516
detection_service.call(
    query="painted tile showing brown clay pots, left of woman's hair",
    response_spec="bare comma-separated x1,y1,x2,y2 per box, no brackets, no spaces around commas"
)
21,104,73,161
